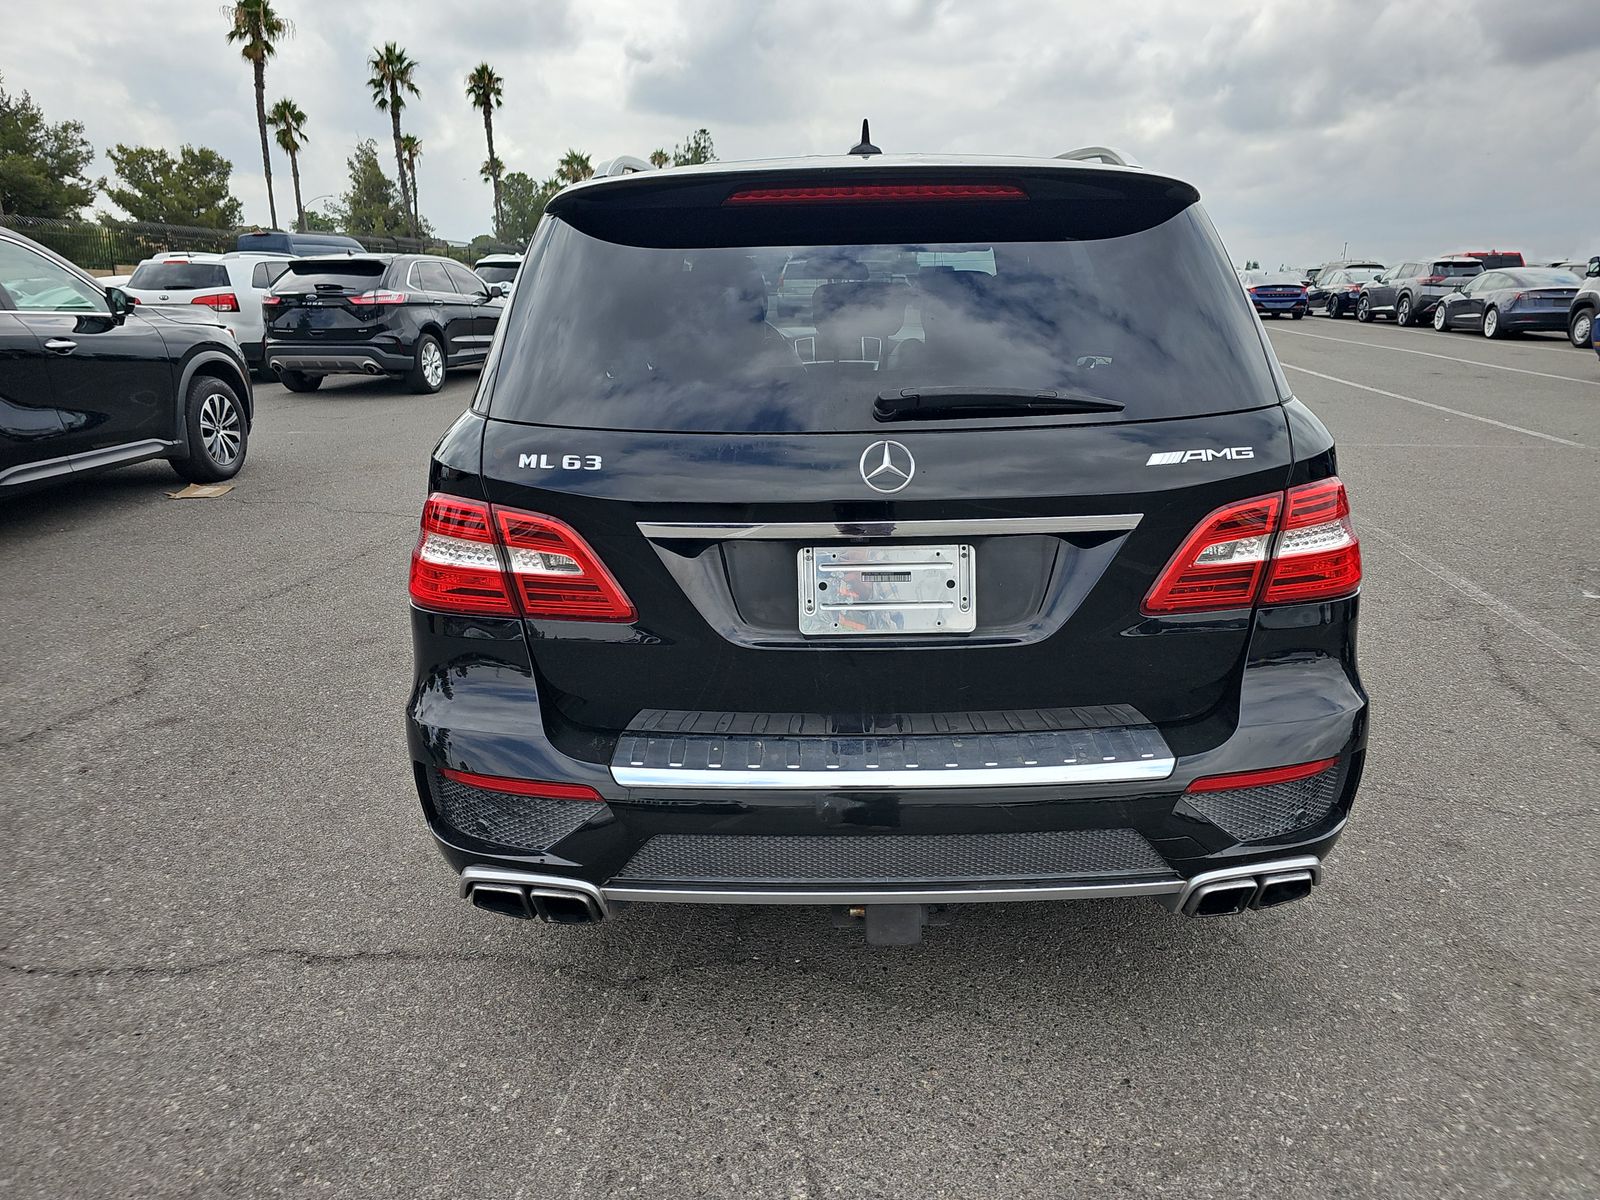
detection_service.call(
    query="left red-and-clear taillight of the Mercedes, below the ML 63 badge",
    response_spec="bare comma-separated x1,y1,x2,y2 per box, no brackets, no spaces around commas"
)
411,493,637,621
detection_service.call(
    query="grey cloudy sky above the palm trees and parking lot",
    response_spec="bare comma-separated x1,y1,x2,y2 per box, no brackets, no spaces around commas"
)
0,0,1600,266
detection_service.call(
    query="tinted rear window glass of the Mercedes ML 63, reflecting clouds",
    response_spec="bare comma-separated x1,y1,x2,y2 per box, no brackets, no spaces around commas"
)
490,205,1278,432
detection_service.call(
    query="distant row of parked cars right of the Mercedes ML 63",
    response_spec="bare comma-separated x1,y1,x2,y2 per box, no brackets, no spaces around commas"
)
1240,251,1600,349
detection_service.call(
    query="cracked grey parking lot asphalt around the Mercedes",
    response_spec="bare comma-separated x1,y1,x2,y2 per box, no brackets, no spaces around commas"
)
9,334,1600,1198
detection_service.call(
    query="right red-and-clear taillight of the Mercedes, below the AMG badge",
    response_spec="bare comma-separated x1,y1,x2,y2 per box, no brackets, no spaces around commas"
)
1142,477,1362,616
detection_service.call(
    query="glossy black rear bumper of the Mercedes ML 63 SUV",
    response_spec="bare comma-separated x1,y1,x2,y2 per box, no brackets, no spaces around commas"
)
408,598,1368,907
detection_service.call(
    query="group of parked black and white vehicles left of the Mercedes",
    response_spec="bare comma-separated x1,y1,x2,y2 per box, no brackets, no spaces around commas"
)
0,227,522,496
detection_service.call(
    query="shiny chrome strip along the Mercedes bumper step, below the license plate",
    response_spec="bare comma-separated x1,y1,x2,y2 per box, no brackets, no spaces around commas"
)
611,757,1178,790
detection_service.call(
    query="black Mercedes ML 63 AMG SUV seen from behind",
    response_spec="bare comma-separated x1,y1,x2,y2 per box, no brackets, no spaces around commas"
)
406,155,1366,942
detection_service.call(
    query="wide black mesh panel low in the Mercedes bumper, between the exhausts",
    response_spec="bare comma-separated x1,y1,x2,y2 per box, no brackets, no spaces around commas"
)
616,829,1171,883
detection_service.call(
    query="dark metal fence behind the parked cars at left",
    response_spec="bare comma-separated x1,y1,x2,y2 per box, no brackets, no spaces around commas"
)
0,214,517,274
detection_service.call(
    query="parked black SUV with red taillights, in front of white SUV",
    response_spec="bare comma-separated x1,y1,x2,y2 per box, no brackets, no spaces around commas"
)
262,254,504,392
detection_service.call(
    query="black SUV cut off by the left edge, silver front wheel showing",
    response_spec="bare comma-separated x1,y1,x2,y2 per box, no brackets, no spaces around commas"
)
0,229,254,496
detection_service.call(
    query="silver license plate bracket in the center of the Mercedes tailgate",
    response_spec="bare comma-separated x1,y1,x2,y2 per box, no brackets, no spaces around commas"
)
797,542,978,637
